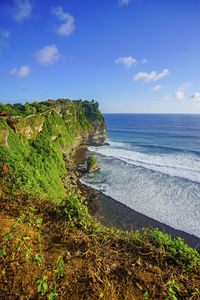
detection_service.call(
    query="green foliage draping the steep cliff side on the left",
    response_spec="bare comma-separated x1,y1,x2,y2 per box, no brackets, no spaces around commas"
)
0,99,106,201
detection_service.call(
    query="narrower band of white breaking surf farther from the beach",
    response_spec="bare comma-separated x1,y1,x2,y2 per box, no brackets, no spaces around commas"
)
89,142,200,183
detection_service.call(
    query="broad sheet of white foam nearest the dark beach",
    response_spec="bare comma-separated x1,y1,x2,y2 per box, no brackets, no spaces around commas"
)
81,157,200,237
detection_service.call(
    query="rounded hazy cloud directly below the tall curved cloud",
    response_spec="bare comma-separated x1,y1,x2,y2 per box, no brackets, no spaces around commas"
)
34,44,60,65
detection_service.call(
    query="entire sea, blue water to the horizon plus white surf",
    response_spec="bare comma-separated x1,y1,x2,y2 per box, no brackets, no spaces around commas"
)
82,114,200,238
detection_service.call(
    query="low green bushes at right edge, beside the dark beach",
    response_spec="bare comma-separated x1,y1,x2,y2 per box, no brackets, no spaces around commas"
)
143,228,200,270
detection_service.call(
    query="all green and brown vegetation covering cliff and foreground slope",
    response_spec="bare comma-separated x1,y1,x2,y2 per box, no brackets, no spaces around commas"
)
0,99,200,300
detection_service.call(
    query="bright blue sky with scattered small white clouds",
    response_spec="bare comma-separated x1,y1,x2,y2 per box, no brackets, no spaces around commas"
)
0,0,200,114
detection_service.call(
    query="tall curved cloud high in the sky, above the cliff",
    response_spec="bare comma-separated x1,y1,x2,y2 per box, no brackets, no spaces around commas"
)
52,6,76,36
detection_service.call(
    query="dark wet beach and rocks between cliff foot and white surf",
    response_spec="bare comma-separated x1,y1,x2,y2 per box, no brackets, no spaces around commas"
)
72,147,200,251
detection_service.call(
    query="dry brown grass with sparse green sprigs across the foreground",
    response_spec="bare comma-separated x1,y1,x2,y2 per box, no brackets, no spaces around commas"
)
0,175,200,300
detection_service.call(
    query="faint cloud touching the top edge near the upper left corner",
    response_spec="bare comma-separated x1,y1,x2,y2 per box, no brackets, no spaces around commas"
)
14,0,32,22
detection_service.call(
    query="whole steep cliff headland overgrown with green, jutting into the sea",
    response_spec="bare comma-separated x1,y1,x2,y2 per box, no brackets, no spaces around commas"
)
0,101,106,201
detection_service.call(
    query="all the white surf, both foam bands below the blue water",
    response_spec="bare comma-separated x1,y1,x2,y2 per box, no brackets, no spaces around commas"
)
82,141,200,237
